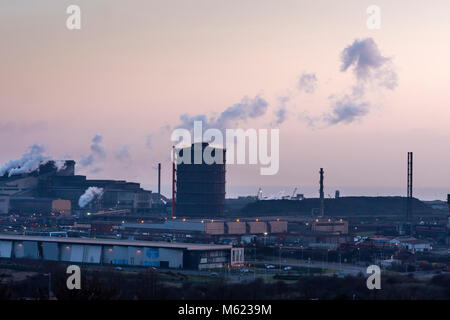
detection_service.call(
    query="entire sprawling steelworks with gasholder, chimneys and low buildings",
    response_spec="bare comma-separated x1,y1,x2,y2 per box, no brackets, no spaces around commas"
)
0,143,450,302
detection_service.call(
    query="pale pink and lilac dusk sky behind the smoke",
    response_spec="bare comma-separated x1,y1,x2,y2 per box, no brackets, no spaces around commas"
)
0,0,450,198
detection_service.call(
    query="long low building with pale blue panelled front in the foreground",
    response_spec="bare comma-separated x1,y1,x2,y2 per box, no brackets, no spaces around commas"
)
0,234,244,270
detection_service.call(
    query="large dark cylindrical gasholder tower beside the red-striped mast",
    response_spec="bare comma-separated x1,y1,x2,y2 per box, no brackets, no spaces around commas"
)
176,142,226,218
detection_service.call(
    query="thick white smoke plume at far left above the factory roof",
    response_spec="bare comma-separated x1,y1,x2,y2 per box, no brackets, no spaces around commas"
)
0,144,54,177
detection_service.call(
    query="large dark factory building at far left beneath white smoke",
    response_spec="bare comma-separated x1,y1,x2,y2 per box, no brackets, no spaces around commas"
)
0,160,152,214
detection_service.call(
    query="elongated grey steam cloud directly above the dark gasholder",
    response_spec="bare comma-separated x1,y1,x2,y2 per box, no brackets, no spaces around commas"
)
178,96,269,130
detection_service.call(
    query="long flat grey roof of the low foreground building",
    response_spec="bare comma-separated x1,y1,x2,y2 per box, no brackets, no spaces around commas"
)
0,234,232,251
